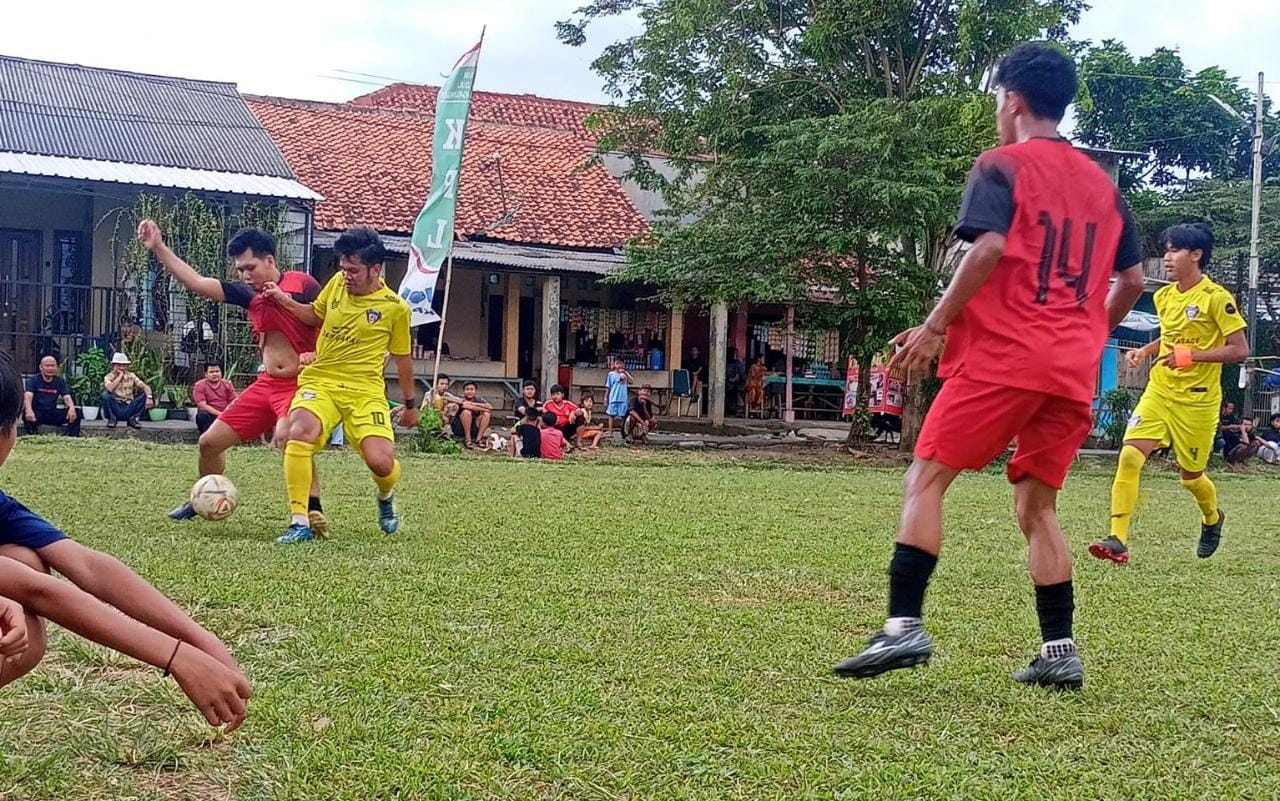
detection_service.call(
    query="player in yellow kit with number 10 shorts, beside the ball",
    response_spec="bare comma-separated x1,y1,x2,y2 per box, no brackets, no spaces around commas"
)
265,228,417,545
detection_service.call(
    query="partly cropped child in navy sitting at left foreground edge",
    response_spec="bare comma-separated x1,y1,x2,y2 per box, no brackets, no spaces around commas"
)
0,352,250,732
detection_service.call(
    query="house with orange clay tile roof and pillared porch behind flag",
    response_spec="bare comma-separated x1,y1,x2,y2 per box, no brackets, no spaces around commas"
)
246,84,682,399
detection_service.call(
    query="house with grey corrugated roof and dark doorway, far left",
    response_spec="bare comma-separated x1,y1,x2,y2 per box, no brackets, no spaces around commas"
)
0,56,320,370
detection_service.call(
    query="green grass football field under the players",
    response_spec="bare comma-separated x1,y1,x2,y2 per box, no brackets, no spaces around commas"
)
0,438,1280,801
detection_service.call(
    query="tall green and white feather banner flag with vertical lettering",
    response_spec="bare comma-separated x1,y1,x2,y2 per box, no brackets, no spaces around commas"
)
399,38,484,325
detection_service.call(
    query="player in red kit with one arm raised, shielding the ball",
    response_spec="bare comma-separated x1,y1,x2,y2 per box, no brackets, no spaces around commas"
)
138,220,328,534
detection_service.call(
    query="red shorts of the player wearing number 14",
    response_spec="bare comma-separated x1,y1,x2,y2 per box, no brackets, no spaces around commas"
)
915,376,1093,489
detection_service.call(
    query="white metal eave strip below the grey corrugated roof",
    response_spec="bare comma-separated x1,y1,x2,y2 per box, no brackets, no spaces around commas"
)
0,152,324,200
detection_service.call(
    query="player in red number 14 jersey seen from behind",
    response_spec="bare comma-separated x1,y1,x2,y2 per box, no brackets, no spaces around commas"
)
836,44,1143,688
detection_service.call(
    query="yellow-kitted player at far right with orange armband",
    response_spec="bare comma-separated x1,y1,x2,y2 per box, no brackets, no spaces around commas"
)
1089,223,1249,564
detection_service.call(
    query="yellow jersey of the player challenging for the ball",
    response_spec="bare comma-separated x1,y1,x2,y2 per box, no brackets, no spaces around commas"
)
300,273,410,393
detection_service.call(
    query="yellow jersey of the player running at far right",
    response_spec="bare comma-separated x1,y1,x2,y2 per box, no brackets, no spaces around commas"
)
1147,276,1245,406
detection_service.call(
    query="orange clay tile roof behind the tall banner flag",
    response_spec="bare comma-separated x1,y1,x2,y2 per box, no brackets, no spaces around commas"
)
244,87,649,248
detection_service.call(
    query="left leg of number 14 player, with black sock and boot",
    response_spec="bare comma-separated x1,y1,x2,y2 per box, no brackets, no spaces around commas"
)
836,458,960,678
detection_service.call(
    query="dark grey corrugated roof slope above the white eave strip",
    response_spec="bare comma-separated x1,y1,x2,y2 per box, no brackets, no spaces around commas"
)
0,55,294,178
